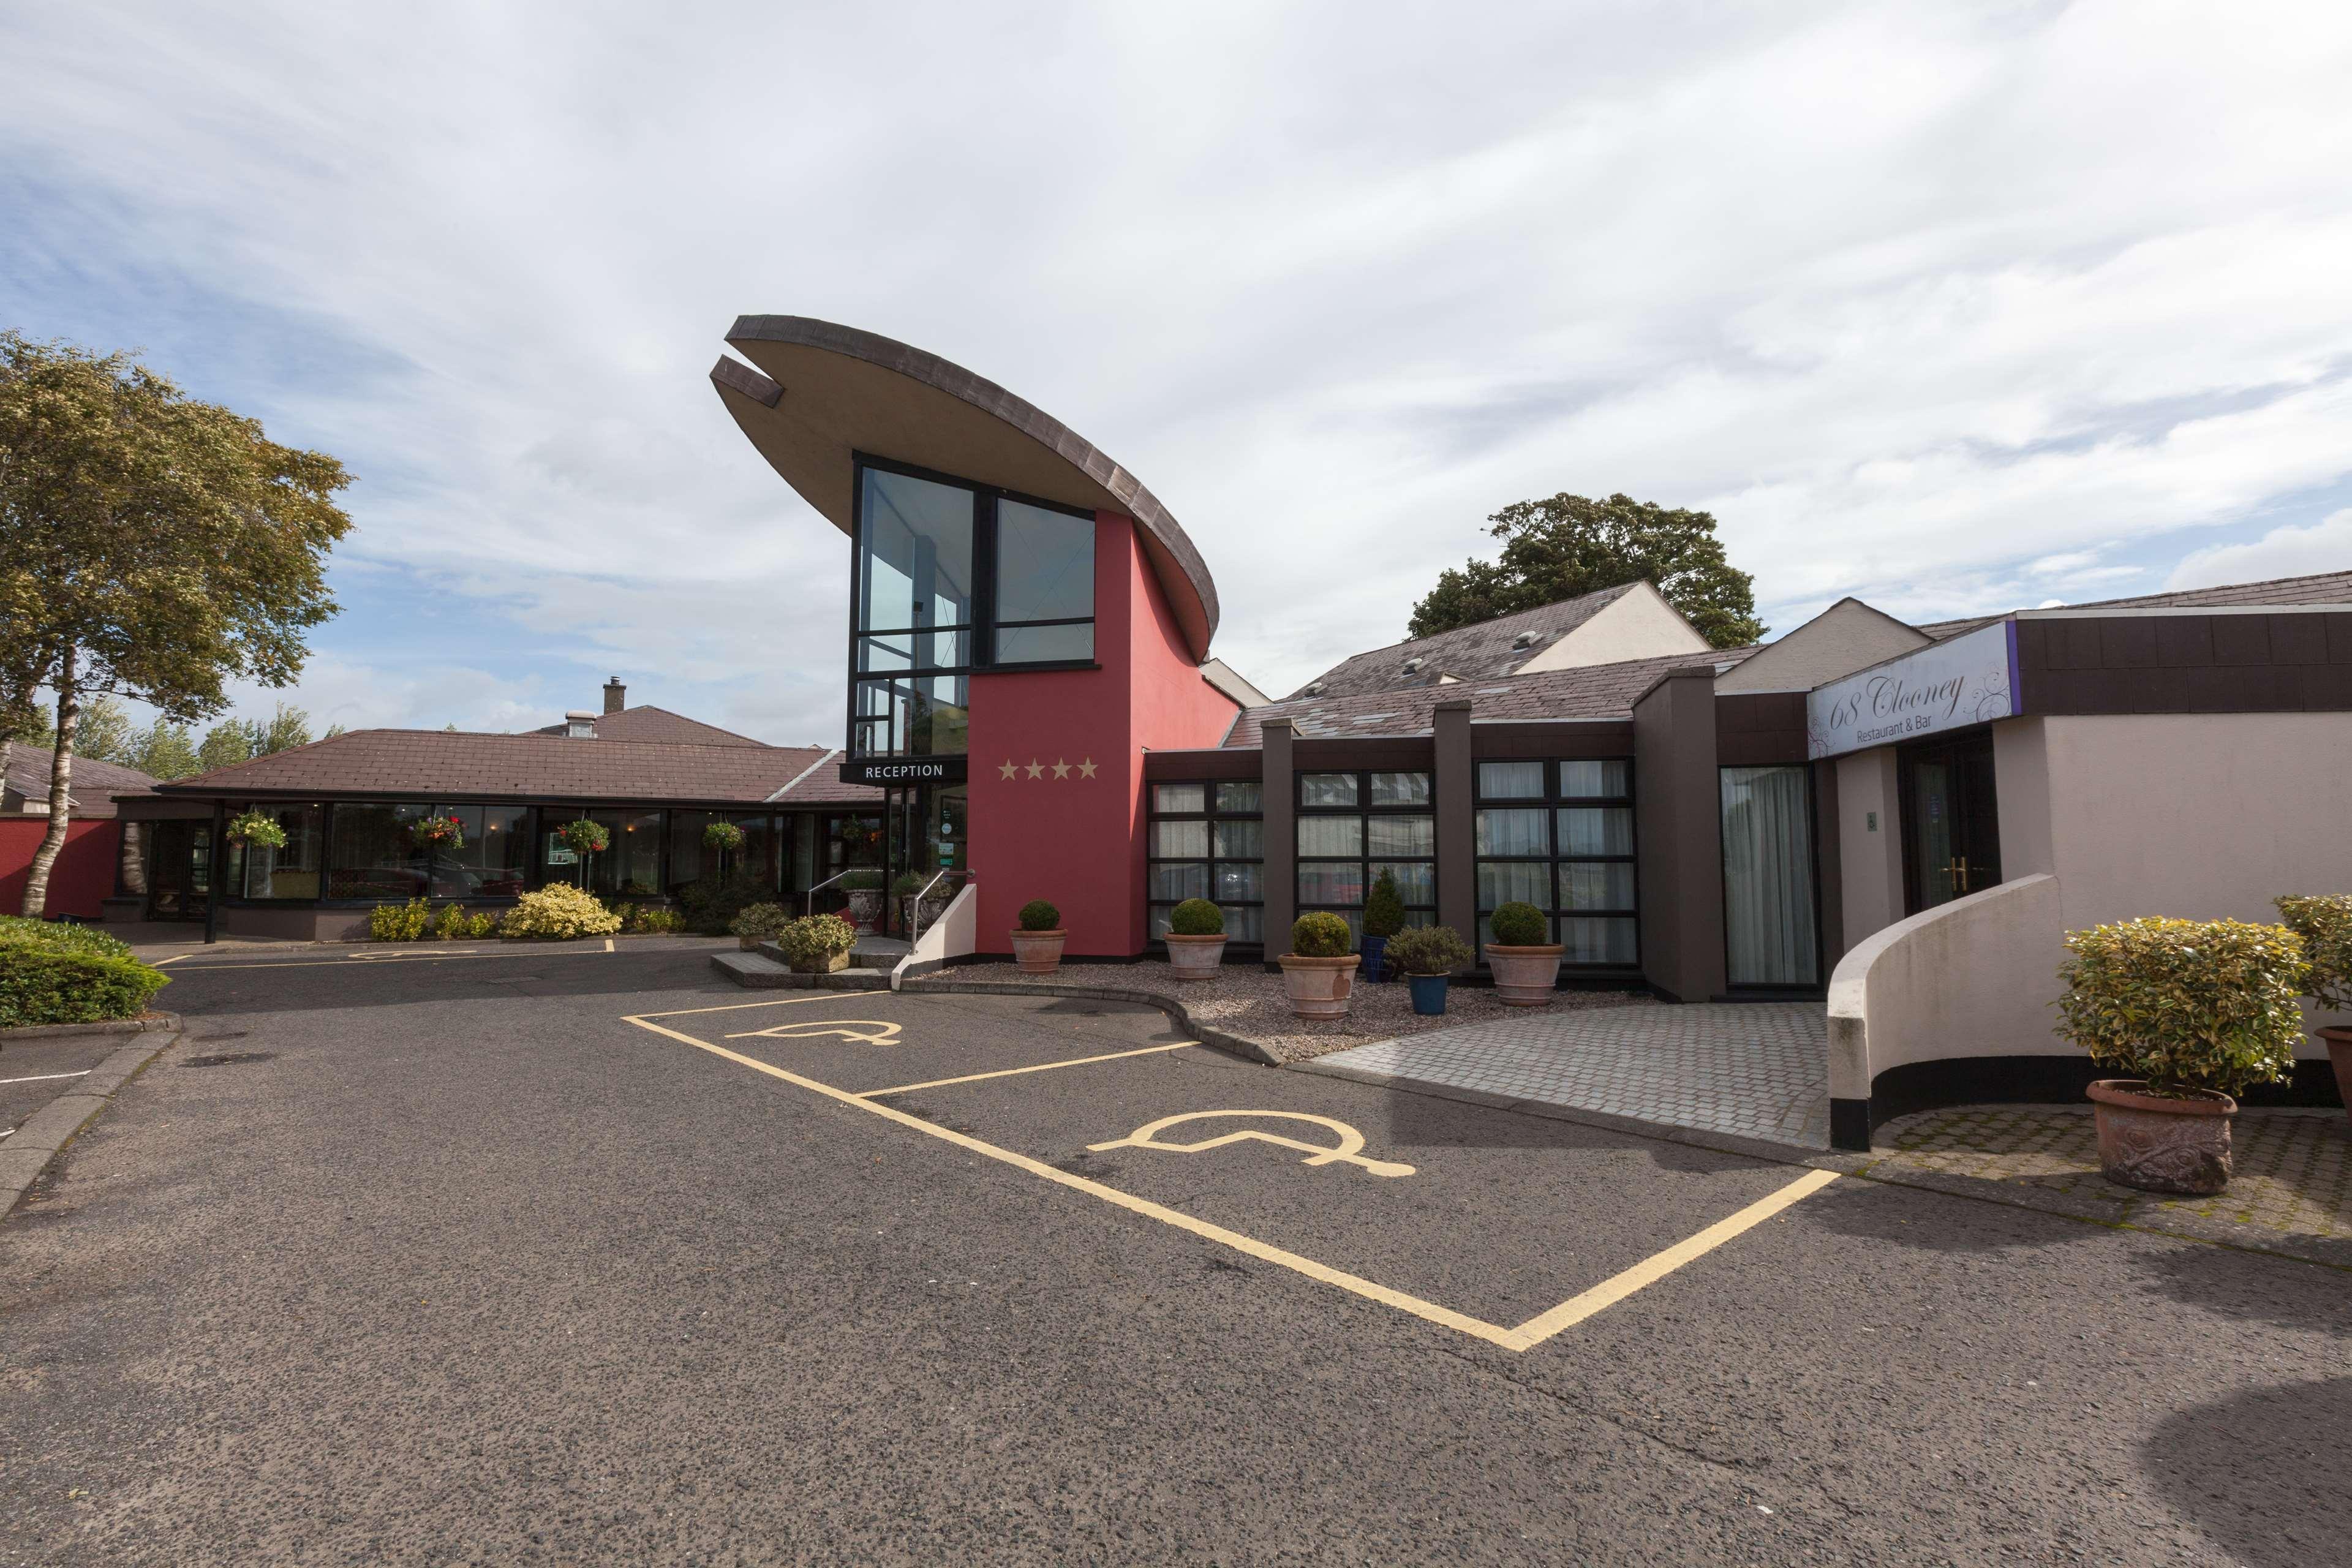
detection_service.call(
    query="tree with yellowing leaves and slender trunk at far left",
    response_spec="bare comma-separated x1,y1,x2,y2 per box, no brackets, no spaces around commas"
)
0,331,350,914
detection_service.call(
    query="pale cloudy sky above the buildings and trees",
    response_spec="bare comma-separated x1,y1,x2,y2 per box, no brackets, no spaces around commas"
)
0,0,2352,743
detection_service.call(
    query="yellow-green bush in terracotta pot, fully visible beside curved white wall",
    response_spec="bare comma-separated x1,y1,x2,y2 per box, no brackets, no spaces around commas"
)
2056,919,2310,1197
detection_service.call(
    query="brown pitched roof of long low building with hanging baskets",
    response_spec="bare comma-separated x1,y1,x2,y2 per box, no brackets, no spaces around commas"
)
151,729,882,806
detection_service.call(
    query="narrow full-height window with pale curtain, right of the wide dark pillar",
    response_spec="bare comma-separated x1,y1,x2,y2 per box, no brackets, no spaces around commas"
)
1722,764,1820,987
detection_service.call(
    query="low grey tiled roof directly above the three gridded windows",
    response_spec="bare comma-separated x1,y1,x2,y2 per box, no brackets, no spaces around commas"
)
1226,649,1755,750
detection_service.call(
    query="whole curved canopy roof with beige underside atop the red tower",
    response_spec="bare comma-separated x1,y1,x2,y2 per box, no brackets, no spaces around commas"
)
710,315,1216,658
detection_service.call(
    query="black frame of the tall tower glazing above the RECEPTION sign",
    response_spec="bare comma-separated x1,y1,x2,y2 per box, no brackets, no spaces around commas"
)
845,451,1103,760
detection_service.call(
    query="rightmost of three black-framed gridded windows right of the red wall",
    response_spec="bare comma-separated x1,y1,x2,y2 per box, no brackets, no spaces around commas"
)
1477,757,1639,966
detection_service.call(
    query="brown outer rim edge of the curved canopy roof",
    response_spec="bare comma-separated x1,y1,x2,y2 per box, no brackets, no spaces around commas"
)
710,315,1218,661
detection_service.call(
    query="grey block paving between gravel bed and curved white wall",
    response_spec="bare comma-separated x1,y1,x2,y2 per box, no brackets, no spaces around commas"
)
1324,1001,1830,1150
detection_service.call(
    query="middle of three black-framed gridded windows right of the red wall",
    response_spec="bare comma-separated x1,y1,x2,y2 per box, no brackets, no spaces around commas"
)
1298,771,1437,940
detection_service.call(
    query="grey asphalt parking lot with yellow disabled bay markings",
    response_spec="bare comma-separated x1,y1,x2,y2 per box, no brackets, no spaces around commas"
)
0,943,2352,1566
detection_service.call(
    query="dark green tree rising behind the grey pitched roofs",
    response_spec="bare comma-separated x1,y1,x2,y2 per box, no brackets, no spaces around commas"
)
1406,494,1766,649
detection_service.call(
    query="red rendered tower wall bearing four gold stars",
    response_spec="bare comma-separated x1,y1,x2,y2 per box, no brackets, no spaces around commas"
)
971,513,1235,957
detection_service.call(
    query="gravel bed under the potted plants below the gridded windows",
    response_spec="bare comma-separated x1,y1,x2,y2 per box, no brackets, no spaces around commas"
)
910,959,1658,1063
